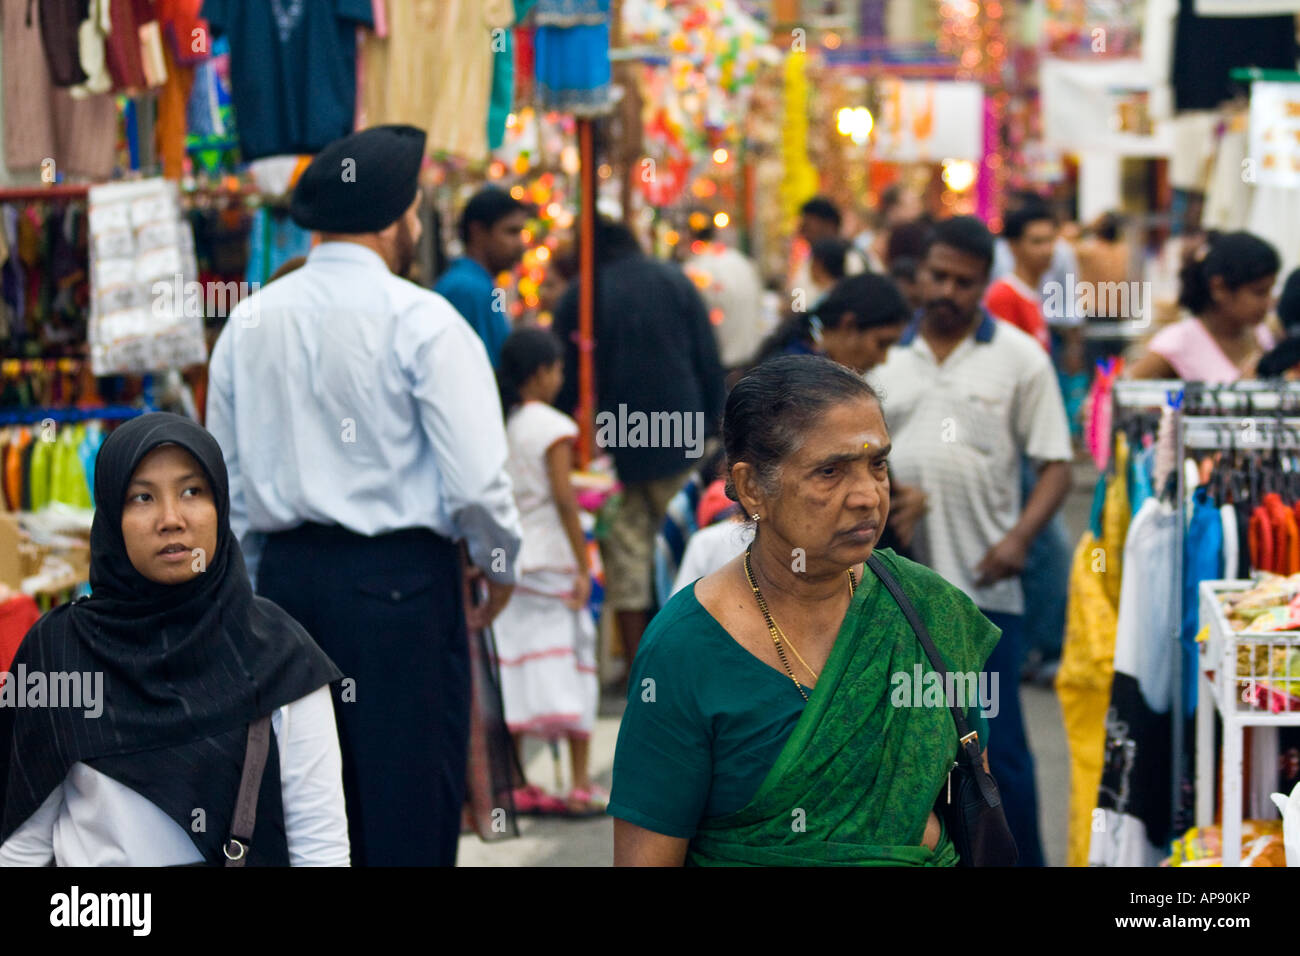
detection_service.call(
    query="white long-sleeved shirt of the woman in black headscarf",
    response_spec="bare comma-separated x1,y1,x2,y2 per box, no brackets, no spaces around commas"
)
0,685,350,866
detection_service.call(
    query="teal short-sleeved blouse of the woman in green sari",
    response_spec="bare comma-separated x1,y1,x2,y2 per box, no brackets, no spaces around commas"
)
608,574,988,839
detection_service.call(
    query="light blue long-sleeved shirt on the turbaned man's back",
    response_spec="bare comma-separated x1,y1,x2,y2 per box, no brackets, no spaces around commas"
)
207,242,520,584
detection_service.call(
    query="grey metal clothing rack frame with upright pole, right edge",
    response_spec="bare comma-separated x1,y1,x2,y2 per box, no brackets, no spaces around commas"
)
1170,381,1300,835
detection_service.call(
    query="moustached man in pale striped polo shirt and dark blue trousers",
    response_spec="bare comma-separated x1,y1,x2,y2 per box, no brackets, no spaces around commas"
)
871,216,1073,866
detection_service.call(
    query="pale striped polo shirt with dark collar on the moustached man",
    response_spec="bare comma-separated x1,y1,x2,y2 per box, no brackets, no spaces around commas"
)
870,312,1073,614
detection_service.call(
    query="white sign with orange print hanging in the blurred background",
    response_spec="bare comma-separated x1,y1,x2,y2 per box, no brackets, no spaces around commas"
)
875,79,984,163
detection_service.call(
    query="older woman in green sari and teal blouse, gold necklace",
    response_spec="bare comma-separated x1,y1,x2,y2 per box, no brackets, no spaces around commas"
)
608,355,1014,866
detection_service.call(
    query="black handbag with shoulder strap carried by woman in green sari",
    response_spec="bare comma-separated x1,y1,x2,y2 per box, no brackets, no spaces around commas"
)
867,554,1018,866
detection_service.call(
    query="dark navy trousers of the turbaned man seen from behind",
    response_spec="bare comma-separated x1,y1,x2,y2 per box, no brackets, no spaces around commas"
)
257,524,471,866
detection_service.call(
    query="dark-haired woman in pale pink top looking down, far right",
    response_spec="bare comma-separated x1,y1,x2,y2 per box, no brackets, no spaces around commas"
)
1130,233,1282,384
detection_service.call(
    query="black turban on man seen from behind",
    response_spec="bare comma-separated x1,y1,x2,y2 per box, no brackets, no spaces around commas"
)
289,126,425,234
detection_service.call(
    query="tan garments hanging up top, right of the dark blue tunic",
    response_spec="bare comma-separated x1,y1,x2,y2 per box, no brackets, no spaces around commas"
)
361,0,515,160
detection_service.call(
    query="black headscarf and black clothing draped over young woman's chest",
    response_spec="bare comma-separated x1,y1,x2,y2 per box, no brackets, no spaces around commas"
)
0,412,342,862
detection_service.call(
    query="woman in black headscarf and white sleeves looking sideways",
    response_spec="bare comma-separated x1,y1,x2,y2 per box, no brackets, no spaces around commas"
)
0,414,348,866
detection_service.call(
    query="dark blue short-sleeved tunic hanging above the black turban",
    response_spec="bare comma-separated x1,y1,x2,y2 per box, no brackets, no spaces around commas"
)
203,0,373,161
